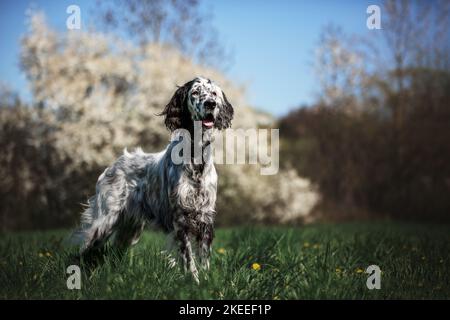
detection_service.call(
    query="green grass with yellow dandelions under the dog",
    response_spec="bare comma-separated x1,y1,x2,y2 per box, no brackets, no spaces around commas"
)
0,223,450,299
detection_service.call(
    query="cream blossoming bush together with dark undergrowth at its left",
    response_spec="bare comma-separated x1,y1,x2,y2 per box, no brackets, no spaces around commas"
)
0,7,318,230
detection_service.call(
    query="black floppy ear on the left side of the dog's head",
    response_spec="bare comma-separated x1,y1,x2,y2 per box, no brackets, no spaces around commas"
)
159,82,191,131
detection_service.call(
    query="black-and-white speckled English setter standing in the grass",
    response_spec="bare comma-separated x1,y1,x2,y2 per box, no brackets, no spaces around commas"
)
75,77,233,282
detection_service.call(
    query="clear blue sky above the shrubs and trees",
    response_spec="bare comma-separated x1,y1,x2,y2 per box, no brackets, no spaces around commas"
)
0,0,381,116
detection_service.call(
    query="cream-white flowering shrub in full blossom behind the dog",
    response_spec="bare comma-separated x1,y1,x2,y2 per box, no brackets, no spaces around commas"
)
0,14,318,230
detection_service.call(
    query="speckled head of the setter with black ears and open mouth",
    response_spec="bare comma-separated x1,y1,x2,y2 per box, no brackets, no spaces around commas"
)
161,77,234,131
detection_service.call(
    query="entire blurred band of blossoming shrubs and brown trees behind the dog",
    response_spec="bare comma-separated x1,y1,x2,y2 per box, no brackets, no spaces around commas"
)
0,0,450,230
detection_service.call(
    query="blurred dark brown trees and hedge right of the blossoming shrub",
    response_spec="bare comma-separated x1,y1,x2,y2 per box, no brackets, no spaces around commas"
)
279,1,450,221
